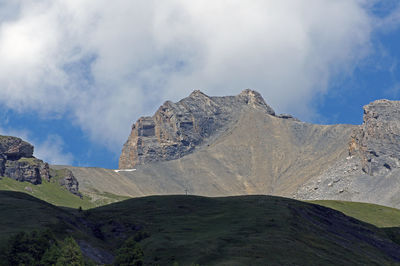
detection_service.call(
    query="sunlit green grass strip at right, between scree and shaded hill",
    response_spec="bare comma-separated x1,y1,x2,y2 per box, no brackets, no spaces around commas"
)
309,200,400,227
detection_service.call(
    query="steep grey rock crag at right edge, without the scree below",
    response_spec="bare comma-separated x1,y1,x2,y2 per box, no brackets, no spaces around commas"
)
349,100,400,176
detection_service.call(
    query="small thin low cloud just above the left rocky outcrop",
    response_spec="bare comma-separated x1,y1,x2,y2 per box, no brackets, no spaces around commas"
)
0,128,74,165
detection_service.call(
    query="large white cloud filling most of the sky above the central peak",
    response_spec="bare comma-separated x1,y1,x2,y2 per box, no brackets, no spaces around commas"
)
0,0,395,151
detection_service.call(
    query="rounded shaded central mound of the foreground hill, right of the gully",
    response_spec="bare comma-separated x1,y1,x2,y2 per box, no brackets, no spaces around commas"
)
88,196,400,265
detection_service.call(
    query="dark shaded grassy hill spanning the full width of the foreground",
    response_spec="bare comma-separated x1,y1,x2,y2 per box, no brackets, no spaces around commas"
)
0,191,400,265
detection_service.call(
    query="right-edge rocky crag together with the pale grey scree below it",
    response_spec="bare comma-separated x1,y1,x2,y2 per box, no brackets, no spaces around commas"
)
293,100,400,207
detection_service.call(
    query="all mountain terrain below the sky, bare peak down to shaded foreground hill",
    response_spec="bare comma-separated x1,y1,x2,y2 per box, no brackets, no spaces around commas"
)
0,90,400,265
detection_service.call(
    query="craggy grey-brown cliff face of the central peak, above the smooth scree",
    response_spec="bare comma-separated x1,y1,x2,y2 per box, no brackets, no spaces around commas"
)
119,90,275,169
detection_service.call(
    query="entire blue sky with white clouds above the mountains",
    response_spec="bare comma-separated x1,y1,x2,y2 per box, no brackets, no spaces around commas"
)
0,0,400,168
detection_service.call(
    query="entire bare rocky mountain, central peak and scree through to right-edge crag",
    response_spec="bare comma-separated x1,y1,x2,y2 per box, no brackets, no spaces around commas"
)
54,90,400,208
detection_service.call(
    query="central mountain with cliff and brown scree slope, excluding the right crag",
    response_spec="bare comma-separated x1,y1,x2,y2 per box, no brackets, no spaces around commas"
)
63,90,356,200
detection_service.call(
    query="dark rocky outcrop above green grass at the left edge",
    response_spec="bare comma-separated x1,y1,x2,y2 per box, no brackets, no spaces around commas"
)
0,136,80,196
